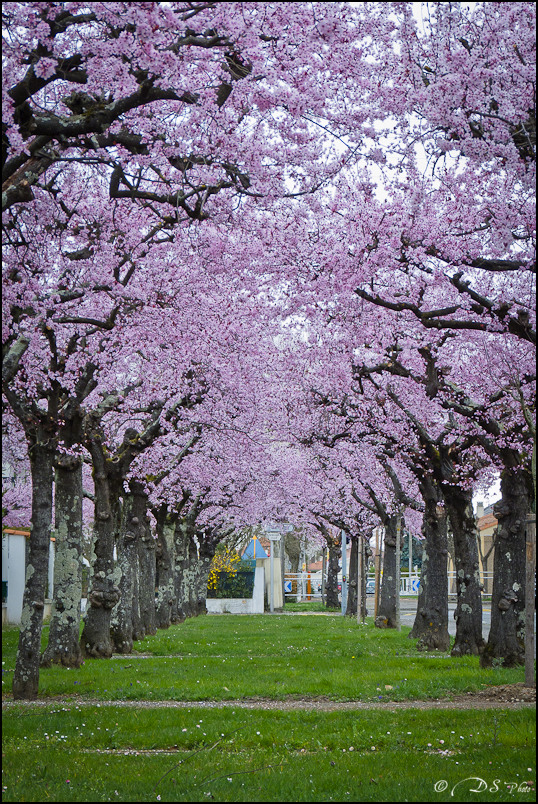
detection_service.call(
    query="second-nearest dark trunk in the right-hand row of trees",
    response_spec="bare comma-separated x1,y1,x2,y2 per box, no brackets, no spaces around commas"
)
443,484,484,656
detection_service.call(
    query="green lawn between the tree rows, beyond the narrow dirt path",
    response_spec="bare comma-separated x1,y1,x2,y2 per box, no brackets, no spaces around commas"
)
2,615,524,701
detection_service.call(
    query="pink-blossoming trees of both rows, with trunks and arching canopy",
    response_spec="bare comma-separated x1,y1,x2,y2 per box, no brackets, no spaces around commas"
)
2,2,536,697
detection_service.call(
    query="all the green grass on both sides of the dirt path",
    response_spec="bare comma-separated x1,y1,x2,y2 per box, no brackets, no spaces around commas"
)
2,615,535,801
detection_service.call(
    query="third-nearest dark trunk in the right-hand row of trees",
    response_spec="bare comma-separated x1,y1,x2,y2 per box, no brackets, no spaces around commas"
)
409,475,450,651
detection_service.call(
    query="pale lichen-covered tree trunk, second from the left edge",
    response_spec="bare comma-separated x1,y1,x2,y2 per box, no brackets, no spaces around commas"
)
41,446,82,667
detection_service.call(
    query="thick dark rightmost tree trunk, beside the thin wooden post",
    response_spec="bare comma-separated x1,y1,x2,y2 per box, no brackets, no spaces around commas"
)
480,466,533,667
